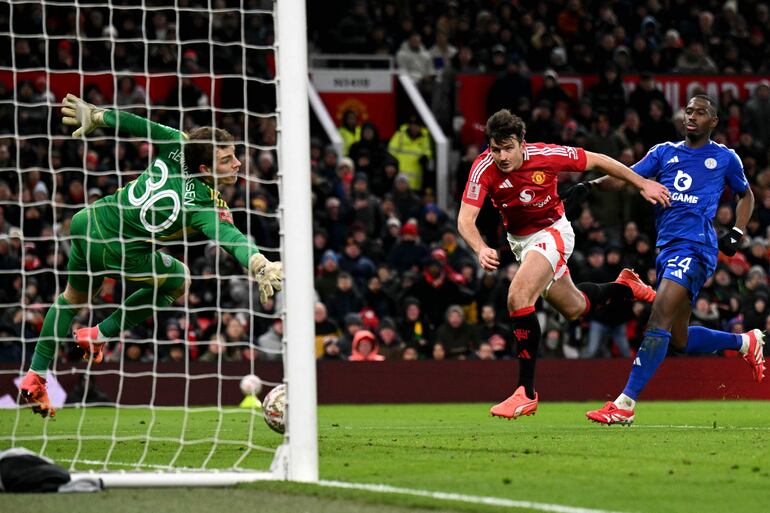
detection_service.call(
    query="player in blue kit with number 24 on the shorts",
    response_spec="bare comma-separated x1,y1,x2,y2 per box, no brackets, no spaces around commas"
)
564,95,765,424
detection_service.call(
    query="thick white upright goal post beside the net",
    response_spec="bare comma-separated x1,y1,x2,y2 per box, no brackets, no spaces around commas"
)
273,0,318,482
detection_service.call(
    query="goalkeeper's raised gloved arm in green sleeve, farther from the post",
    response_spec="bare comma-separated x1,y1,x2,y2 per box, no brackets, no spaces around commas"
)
61,94,186,141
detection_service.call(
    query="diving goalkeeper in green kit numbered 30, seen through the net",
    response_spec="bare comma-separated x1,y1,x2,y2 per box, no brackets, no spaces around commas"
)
20,94,283,417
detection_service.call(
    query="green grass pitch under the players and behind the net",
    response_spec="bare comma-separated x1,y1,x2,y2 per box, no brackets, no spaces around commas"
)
0,401,770,513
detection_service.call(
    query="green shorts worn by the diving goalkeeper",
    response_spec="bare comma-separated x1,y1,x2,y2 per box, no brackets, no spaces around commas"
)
67,208,187,295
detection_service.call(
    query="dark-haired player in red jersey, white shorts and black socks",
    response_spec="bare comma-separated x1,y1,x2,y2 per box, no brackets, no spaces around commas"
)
457,110,670,418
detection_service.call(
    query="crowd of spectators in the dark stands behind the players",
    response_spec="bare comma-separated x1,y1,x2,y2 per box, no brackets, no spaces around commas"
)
0,0,770,361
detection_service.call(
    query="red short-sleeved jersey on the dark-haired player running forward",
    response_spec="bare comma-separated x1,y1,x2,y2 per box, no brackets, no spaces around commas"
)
463,142,586,236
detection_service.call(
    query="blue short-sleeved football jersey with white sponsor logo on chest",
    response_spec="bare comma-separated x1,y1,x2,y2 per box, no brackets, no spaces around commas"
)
631,141,749,248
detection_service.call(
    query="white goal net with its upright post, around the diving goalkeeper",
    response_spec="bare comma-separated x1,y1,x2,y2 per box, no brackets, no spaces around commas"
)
0,0,318,486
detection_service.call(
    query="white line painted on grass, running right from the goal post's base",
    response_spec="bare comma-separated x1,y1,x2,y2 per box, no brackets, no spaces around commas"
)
318,481,620,513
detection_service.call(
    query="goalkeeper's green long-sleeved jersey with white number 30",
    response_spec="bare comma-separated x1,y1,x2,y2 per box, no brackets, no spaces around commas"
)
89,110,259,267
